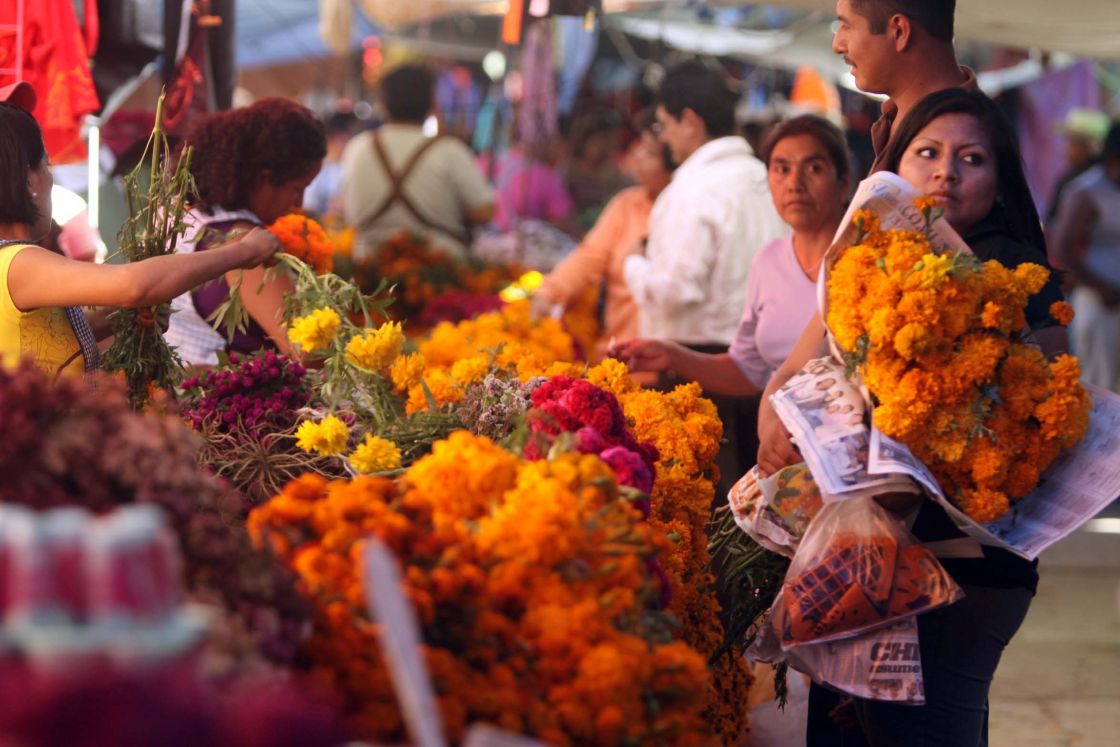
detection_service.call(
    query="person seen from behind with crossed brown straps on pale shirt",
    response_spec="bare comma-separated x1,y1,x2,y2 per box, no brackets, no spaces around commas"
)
340,65,494,260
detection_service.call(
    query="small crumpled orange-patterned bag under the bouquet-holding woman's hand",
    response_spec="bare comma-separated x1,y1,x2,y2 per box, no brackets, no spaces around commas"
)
727,463,822,558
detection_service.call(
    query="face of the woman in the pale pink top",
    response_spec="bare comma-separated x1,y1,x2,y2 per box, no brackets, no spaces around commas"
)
768,134,848,232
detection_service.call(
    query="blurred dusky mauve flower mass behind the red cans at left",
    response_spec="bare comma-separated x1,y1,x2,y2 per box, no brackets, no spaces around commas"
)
0,362,310,667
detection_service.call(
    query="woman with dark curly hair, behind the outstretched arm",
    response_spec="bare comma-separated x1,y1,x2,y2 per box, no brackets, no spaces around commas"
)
165,99,327,365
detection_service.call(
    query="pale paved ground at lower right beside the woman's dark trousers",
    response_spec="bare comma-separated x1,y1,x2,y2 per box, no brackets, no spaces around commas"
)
747,504,1120,747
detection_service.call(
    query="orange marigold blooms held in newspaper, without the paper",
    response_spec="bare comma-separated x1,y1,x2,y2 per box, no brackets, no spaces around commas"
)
827,200,1091,523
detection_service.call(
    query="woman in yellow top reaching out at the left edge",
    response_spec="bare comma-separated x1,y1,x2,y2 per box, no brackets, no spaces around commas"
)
0,103,280,375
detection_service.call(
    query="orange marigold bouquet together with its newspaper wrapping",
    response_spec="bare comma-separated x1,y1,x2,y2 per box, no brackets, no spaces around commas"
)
797,172,1120,559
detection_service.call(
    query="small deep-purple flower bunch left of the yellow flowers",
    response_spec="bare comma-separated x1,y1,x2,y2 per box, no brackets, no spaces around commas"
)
183,351,311,432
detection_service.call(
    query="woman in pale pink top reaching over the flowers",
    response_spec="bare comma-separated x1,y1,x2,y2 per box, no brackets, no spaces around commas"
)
610,114,851,395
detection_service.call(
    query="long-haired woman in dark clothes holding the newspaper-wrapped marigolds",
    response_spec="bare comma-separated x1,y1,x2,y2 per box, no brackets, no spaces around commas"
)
758,88,1066,747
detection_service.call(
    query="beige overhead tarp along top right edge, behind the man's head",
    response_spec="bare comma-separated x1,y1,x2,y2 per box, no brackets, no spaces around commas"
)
712,0,1120,59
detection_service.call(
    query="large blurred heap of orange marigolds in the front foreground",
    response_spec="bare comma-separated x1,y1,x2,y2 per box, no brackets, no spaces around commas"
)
250,439,715,745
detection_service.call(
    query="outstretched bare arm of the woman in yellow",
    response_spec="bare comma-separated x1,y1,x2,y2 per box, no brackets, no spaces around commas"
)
8,228,280,311
